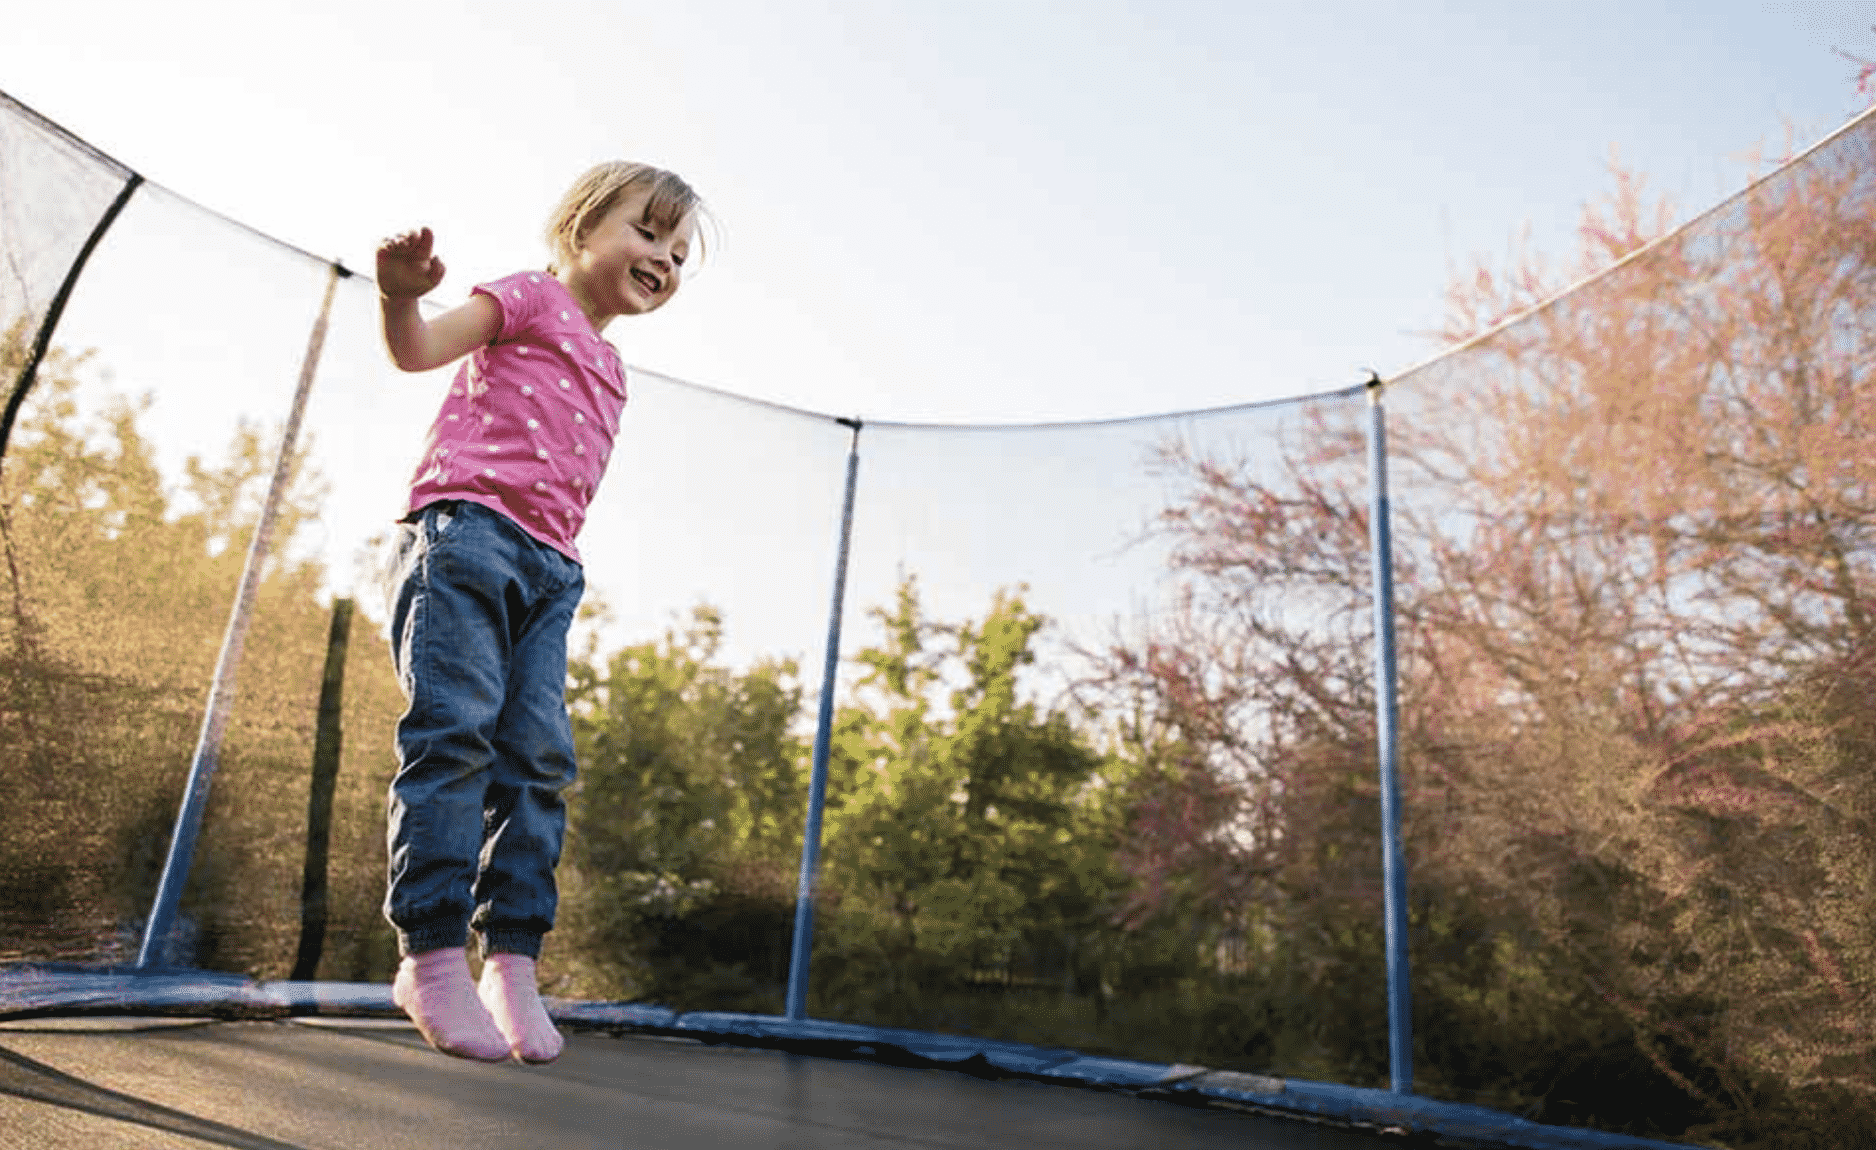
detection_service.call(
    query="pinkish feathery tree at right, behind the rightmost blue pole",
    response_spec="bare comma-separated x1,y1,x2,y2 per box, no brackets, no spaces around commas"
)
1112,129,1876,1137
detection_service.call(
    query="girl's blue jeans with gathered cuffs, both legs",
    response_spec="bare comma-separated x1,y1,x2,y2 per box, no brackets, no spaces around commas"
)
385,503,585,957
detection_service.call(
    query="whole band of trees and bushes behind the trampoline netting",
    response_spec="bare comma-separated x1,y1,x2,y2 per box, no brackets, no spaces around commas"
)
0,118,1876,1146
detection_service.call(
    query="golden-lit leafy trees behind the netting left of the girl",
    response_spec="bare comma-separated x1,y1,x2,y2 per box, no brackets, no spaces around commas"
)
0,333,401,977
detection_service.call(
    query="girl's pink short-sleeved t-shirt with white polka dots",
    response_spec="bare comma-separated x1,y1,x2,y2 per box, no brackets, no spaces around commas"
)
409,272,625,563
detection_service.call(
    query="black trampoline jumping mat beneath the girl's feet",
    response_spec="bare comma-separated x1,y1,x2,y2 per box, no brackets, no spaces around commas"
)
0,1019,1399,1150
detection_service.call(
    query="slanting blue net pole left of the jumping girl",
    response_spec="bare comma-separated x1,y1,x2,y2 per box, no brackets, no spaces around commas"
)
137,265,351,970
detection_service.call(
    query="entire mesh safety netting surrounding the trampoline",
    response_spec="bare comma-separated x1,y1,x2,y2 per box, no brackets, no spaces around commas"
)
0,85,1876,1144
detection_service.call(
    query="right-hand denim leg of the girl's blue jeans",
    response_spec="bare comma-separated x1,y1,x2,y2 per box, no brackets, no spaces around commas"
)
475,566,585,959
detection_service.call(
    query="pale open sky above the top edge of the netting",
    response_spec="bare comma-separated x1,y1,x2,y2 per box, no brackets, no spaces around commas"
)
0,0,1876,424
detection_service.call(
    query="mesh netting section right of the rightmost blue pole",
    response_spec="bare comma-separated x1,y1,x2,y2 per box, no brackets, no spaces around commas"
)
1390,120,1876,1144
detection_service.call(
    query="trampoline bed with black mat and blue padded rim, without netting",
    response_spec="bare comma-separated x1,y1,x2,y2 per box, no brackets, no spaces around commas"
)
0,966,1703,1150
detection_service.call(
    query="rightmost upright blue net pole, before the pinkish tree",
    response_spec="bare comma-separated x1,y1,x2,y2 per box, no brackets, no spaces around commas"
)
1368,375,1413,1094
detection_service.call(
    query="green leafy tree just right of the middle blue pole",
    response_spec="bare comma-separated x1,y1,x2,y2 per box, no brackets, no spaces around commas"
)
816,580,1124,1021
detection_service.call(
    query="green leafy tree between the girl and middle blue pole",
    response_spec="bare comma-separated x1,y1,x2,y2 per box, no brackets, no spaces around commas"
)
550,606,807,1006
